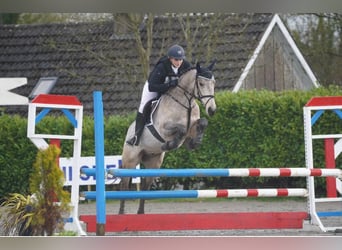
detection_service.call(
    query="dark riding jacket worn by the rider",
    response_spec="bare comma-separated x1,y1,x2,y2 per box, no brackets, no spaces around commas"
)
148,56,191,94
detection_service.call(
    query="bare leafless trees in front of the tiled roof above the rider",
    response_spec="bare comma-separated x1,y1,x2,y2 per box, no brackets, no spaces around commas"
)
114,13,224,79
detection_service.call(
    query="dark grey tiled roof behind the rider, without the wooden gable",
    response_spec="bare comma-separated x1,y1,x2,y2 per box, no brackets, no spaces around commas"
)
0,14,273,115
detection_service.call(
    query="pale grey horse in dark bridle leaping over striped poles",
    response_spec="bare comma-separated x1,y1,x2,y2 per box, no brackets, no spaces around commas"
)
119,61,216,214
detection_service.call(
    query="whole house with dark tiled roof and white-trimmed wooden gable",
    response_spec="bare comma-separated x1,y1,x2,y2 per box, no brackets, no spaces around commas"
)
0,14,318,115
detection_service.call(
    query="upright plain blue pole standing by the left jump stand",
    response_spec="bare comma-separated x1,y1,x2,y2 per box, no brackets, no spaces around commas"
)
93,91,106,236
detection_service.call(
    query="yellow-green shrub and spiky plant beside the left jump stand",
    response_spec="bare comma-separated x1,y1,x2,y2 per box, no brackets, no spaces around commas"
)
0,145,70,236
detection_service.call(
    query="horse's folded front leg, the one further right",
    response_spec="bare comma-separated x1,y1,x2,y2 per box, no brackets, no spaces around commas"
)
184,118,208,150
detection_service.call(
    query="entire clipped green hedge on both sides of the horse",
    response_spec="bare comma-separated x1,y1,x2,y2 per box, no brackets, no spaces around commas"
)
0,87,342,197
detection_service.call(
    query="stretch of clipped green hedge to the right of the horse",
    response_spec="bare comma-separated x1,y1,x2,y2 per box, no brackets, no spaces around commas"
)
163,87,342,189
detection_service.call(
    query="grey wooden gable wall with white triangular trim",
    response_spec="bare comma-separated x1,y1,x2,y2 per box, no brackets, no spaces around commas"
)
233,15,319,92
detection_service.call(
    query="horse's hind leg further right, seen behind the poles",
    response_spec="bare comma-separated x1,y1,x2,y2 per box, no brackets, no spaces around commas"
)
138,152,165,214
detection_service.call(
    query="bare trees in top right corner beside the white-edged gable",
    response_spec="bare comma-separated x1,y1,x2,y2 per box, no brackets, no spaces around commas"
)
286,13,342,86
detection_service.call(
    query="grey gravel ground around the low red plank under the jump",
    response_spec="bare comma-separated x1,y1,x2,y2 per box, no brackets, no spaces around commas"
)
79,198,342,237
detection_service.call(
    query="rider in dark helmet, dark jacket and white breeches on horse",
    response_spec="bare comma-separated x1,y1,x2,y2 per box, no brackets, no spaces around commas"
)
126,44,191,145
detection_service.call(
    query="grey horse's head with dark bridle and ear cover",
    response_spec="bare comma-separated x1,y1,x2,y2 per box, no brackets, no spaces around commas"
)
196,61,216,116
